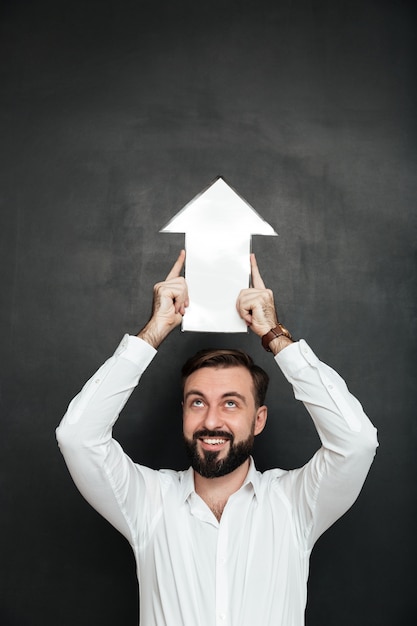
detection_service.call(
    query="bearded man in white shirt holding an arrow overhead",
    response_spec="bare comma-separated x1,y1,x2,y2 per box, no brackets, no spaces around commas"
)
57,251,378,626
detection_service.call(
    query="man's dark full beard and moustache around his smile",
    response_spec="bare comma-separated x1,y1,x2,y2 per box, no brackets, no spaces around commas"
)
184,424,255,478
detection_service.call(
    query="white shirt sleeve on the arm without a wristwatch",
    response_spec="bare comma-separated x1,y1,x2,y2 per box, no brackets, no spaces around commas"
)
56,335,159,543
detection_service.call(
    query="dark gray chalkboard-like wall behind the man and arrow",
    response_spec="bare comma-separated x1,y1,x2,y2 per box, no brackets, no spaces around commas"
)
0,0,417,626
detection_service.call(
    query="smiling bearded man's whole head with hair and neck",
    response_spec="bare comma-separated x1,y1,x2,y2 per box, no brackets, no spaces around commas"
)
182,350,268,504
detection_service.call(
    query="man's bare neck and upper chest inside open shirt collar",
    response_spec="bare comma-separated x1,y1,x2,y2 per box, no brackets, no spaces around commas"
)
194,459,250,521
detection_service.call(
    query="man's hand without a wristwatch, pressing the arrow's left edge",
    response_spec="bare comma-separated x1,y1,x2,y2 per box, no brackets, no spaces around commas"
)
138,250,189,348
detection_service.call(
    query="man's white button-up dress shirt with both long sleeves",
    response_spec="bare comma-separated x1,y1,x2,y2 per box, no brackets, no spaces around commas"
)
57,335,378,626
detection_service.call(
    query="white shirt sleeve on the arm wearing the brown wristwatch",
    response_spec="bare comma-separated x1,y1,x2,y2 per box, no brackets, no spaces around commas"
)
275,340,378,549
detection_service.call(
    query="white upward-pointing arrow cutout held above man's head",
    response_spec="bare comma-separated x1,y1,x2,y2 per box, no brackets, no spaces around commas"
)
160,177,277,333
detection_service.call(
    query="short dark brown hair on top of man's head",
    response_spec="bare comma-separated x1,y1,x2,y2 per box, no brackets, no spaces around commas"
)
181,348,269,408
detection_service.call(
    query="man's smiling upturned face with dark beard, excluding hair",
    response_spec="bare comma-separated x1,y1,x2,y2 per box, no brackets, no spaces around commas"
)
183,366,267,478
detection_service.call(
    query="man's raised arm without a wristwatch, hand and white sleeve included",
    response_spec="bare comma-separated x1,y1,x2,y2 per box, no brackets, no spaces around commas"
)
56,251,188,541
